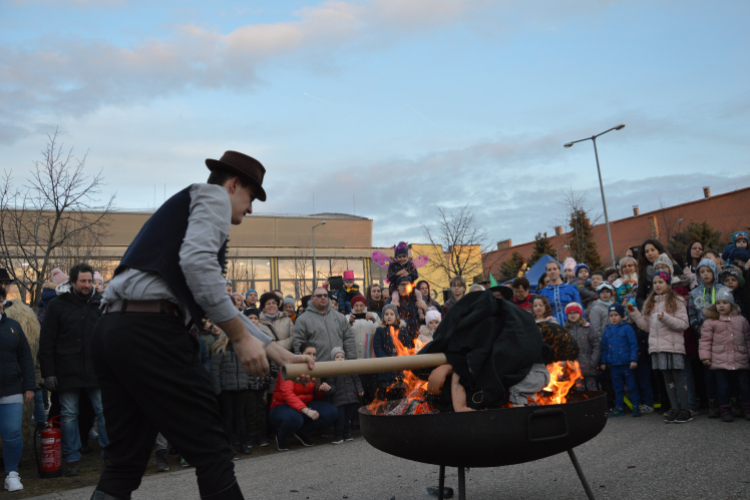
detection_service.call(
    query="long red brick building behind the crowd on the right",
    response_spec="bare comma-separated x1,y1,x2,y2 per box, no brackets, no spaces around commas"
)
482,187,750,276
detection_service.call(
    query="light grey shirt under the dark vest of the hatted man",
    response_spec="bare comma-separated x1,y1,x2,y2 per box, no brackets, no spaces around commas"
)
102,184,272,345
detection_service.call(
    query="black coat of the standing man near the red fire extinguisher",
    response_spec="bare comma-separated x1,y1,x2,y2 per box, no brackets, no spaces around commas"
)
39,289,102,391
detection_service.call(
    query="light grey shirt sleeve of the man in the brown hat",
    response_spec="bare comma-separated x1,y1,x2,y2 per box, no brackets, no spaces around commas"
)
180,184,271,345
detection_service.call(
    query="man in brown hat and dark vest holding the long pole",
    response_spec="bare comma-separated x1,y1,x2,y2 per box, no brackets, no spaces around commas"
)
92,151,313,500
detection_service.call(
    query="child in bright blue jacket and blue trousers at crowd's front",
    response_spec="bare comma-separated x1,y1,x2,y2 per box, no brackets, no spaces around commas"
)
601,303,641,417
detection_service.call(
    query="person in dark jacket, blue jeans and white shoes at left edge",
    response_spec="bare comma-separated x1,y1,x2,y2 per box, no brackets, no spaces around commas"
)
0,287,35,491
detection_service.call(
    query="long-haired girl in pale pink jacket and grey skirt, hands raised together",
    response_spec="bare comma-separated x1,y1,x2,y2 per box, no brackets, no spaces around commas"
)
628,271,693,424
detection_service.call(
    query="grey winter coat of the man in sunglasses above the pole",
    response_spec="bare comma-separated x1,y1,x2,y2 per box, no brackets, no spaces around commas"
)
292,301,357,361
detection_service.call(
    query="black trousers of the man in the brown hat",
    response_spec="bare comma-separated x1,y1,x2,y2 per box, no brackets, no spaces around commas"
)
92,313,244,499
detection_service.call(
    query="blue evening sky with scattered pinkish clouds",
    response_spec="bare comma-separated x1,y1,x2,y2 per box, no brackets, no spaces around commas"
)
0,0,750,246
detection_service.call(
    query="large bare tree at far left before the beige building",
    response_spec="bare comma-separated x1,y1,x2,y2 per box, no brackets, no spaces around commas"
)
0,130,115,304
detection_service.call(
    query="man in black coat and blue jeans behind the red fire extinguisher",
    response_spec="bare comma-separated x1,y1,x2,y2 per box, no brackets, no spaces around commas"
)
39,264,109,476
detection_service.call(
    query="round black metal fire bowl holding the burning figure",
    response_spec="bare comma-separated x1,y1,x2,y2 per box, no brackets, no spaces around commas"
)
359,392,607,467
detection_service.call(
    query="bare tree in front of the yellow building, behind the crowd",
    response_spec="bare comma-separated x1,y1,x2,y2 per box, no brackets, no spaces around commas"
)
422,205,487,286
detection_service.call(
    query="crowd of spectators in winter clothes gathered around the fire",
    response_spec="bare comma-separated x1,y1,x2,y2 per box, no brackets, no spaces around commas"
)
0,231,750,491
